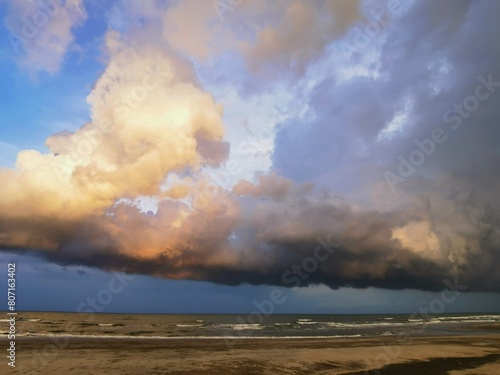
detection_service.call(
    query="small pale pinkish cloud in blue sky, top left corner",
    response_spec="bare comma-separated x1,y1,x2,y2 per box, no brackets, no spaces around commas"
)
4,0,87,74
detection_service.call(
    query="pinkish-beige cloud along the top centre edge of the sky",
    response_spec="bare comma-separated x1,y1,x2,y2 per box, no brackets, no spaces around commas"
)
110,0,361,78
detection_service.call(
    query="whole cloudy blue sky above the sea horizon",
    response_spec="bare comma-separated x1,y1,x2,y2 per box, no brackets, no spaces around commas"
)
0,0,500,313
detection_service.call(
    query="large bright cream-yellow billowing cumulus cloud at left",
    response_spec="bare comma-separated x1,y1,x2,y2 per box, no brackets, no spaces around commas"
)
0,32,224,248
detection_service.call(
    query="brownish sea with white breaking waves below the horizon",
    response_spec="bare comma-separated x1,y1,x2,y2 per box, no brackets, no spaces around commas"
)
0,312,500,339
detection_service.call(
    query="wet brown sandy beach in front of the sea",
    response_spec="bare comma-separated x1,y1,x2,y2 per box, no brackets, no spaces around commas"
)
2,334,500,375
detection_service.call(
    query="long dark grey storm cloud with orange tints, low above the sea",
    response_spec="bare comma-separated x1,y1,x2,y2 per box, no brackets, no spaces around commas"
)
6,177,500,291
